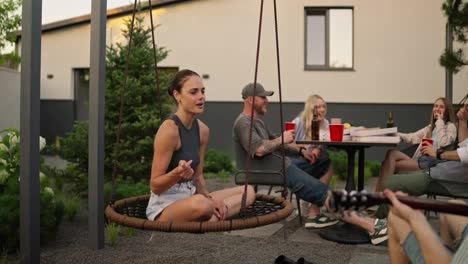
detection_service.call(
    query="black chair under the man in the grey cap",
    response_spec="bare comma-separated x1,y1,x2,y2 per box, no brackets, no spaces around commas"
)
234,170,302,225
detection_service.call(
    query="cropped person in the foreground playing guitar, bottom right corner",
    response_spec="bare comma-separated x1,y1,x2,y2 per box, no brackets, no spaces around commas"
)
384,190,468,264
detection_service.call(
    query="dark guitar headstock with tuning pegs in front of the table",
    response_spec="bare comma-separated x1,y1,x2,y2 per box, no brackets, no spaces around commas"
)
331,190,380,211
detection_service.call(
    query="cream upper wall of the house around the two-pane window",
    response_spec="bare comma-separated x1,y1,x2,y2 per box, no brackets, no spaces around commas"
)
31,0,468,103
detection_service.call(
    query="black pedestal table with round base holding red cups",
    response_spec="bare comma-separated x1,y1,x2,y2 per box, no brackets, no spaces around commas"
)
296,140,398,244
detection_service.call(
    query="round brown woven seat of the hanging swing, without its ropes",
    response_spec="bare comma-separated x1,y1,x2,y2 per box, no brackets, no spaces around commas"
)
105,194,293,233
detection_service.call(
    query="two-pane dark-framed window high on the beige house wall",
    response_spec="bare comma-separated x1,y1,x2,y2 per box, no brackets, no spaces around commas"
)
305,7,353,70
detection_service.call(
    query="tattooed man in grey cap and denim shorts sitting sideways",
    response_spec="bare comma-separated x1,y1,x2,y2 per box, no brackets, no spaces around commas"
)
233,83,338,228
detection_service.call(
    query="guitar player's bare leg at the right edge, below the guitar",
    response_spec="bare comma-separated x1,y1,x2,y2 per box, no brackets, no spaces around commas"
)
440,200,468,246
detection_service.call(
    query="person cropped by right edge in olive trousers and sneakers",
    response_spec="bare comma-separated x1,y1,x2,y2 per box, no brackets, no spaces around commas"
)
344,104,468,244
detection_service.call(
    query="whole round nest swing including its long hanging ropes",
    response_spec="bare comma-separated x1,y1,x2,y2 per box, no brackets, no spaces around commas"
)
105,0,293,233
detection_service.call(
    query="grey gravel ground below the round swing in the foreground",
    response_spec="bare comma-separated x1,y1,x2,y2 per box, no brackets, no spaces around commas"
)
41,175,362,264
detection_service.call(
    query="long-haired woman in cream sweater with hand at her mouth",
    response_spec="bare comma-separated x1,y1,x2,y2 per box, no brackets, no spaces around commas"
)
375,97,457,192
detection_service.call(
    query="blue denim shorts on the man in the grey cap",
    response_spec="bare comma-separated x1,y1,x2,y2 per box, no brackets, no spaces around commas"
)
286,164,328,206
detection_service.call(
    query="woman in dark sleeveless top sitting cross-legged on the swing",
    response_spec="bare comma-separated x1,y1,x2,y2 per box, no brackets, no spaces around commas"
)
146,70,255,222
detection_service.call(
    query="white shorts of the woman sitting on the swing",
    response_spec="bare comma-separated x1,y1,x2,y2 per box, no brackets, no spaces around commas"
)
146,181,196,220
